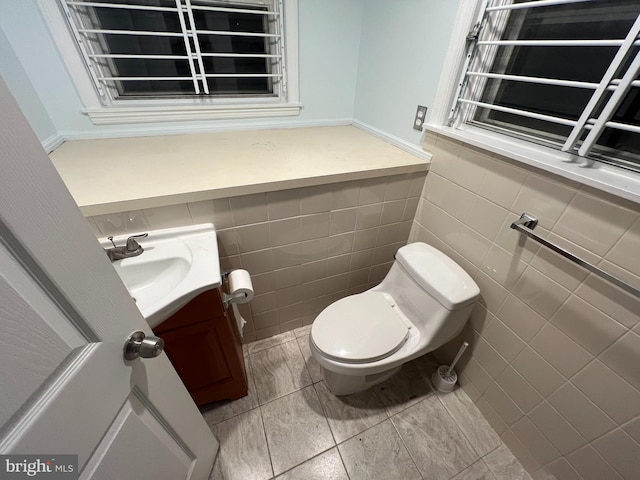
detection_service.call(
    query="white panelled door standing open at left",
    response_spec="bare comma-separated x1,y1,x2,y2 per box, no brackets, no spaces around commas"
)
0,79,218,480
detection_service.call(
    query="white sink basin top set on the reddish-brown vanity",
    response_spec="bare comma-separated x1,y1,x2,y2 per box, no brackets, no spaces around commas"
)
100,223,221,328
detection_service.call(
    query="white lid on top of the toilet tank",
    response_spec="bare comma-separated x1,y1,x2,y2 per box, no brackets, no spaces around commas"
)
396,242,480,311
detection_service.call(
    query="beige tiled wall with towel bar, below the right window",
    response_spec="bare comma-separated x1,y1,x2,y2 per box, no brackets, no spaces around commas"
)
410,131,640,479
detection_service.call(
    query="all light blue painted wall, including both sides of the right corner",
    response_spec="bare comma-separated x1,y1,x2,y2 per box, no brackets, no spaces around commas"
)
0,0,459,145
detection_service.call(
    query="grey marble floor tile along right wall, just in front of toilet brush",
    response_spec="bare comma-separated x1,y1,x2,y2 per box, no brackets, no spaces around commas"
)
436,388,502,457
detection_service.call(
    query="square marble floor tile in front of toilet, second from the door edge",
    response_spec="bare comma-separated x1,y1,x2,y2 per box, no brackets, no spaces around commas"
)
260,386,335,475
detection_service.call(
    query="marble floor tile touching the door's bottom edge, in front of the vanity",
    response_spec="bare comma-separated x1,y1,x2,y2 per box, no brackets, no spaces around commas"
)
212,408,273,480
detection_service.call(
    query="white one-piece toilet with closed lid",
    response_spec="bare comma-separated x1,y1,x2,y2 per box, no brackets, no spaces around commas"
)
309,243,480,395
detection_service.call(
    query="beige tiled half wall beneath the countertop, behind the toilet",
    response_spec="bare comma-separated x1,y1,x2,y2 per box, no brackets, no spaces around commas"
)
88,173,424,342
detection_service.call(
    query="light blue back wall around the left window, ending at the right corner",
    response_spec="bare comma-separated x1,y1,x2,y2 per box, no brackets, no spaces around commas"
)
0,0,363,140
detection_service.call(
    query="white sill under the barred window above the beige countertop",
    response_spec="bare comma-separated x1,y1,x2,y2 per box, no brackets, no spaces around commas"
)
82,103,302,125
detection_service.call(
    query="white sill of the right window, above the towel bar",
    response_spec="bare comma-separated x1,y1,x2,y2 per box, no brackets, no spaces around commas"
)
424,124,640,204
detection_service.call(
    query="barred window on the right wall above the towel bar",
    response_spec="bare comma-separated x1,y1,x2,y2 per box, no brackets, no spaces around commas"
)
449,0,640,171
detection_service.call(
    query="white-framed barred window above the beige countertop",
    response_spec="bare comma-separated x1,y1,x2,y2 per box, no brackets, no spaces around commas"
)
40,0,300,123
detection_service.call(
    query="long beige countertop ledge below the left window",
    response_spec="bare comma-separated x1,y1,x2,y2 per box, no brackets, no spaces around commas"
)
50,126,428,216
